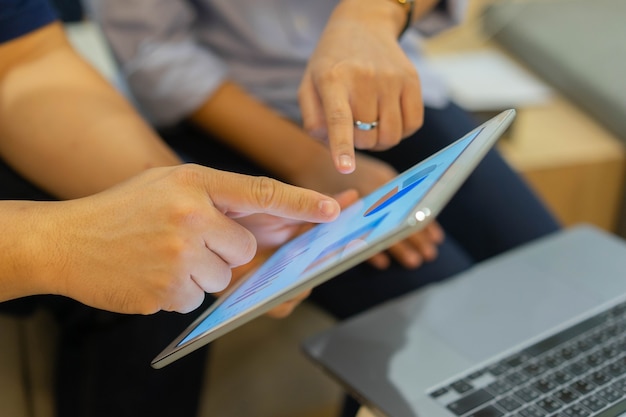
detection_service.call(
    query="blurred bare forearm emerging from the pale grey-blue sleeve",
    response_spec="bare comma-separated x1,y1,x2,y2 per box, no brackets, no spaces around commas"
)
190,82,329,182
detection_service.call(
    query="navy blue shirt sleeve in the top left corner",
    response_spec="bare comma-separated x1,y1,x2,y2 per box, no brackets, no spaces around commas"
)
0,0,56,43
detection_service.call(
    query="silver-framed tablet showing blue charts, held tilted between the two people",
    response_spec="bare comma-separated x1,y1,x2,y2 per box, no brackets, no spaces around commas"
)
152,110,515,368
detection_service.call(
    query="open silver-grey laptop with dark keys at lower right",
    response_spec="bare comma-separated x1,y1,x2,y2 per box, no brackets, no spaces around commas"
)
303,225,626,417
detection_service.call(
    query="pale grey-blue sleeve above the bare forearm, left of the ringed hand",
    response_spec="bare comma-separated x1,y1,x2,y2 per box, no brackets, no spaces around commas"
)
91,0,227,127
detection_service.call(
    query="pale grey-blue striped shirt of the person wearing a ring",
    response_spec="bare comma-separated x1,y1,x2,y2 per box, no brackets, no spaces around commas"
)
91,0,467,127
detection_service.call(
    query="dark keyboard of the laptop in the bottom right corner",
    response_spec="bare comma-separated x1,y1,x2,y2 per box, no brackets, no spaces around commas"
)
430,302,626,417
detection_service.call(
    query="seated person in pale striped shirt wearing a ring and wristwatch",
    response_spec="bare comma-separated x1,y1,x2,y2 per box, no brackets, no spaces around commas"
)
92,0,559,415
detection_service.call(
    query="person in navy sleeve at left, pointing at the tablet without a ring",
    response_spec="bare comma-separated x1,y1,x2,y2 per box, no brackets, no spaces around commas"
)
0,0,346,416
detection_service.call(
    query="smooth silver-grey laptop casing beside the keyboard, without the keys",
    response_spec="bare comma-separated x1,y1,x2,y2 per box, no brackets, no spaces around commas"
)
304,226,626,417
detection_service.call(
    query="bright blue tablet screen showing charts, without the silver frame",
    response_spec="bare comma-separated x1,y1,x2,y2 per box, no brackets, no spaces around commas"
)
177,130,480,346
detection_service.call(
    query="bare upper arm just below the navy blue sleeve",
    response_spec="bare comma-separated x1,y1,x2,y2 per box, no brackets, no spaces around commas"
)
0,24,180,198
